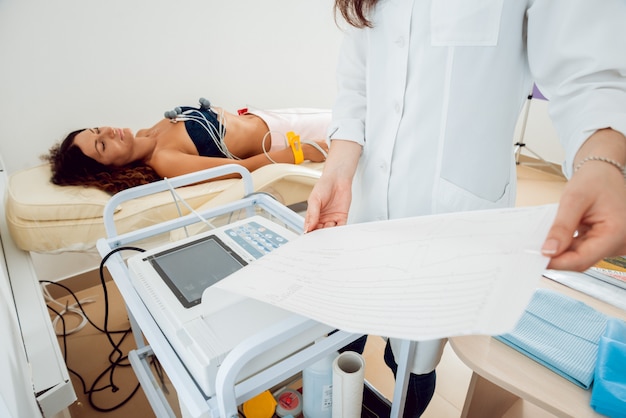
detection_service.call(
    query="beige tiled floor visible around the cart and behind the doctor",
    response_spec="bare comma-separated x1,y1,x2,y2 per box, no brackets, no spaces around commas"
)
50,165,565,418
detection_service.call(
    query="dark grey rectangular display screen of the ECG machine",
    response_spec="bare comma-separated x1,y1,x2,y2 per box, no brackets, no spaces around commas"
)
147,235,247,308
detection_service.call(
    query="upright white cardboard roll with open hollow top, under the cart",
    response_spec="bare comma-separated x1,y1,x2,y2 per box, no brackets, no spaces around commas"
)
333,351,365,418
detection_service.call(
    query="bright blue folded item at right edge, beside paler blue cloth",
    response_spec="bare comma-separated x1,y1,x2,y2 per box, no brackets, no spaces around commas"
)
591,318,626,418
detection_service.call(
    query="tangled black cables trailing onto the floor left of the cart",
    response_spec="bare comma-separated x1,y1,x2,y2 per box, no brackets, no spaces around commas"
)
40,247,145,412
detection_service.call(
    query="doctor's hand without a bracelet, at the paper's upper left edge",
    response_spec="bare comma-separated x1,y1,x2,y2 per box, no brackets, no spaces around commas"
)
304,140,362,233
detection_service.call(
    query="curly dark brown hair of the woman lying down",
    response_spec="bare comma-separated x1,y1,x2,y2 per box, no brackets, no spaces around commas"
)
42,129,161,194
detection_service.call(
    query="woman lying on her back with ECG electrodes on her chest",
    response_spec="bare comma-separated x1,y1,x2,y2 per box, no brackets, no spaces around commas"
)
44,99,330,193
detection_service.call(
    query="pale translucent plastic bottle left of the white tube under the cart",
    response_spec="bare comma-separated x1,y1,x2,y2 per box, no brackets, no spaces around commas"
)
302,352,339,418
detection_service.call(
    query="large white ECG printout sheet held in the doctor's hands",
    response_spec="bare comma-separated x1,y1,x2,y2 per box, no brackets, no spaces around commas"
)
214,205,557,340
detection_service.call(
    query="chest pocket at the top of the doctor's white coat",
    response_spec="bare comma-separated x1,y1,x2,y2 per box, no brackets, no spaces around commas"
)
430,0,504,46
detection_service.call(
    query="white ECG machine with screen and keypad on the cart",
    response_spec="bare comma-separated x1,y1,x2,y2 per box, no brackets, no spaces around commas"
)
128,215,331,397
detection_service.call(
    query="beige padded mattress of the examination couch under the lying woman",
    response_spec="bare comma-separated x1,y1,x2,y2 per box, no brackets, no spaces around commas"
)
5,163,322,253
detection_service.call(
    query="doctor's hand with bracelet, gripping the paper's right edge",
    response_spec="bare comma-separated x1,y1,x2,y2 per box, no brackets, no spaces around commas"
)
542,129,626,271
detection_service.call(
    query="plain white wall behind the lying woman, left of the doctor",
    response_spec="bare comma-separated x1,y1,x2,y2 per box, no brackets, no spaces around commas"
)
0,0,341,173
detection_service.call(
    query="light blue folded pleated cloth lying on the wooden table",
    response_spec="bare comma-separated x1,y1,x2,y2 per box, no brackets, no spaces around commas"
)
495,289,607,389
